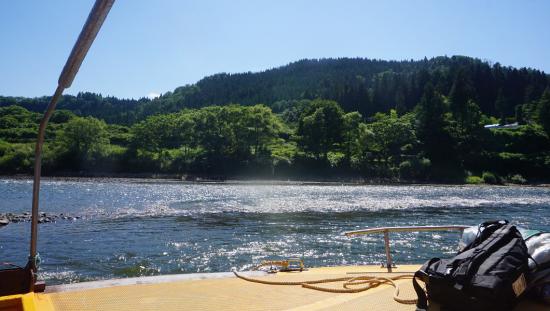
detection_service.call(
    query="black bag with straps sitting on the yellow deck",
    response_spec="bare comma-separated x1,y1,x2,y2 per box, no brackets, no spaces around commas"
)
413,221,529,311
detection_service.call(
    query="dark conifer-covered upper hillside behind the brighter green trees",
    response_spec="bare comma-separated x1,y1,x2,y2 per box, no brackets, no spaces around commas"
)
0,56,550,125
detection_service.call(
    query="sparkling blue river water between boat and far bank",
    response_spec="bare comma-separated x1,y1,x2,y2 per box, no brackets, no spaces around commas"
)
0,179,550,284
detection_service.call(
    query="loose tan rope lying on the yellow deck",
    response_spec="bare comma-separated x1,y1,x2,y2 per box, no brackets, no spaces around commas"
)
233,271,416,304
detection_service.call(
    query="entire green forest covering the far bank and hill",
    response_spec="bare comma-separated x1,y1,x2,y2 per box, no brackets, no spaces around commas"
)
0,56,550,183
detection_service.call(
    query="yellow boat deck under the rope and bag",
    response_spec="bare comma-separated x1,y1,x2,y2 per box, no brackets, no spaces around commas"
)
0,265,548,311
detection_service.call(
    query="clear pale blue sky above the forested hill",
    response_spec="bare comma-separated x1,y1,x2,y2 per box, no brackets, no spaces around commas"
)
0,0,550,98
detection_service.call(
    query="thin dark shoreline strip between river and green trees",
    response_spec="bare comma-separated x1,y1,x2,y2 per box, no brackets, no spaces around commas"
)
0,174,550,188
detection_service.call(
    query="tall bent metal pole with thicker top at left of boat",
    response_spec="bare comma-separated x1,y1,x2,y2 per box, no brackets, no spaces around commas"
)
28,0,115,289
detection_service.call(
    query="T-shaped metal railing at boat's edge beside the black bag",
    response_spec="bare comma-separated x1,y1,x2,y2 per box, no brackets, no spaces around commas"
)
344,225,469,272
